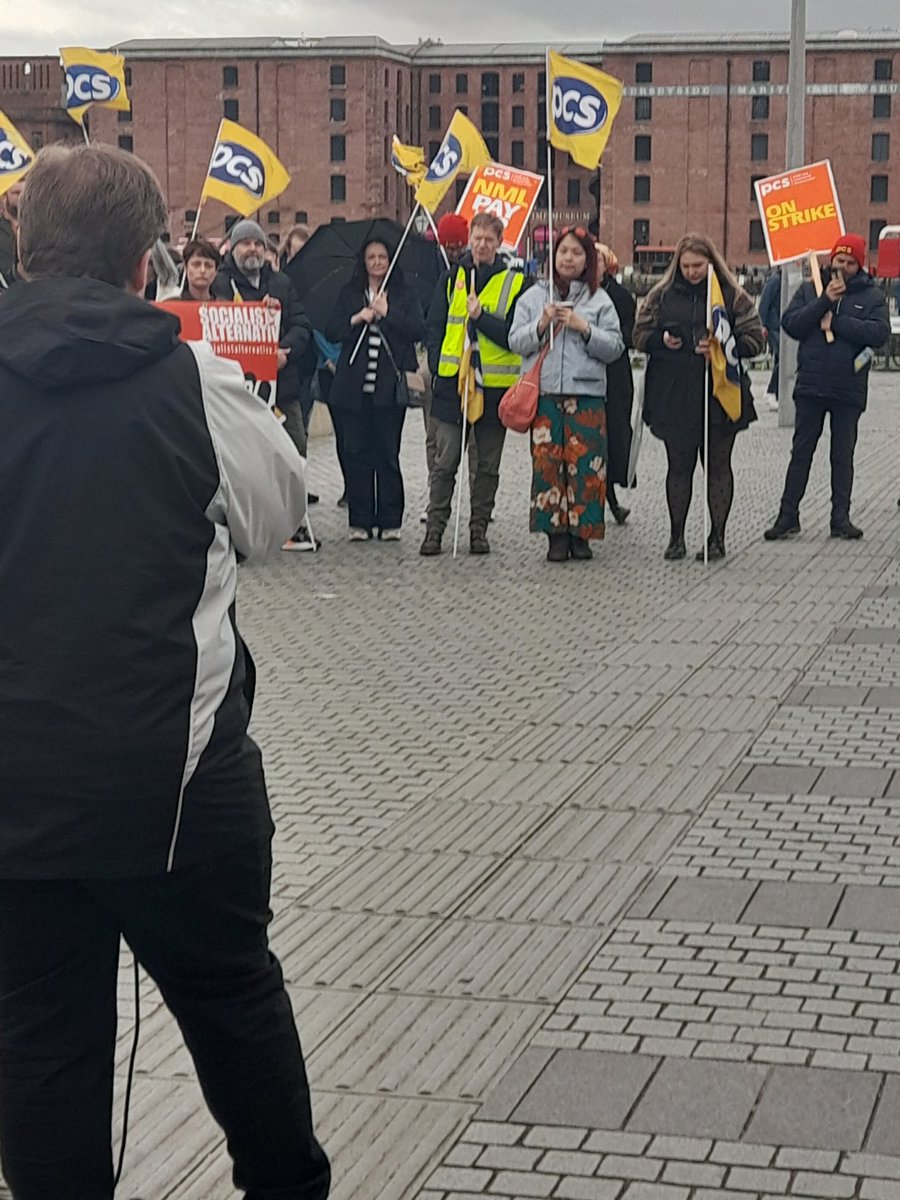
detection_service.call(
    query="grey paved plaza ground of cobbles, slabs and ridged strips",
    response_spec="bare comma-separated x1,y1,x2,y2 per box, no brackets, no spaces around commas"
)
10,374,900,1200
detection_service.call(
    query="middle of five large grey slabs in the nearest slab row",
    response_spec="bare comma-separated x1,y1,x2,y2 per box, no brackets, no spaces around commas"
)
628,1058,766,1140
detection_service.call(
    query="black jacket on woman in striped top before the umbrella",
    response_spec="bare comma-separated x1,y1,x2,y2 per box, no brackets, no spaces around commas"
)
325,271,425,412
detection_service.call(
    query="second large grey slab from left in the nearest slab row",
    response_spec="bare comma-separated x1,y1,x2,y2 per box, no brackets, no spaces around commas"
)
512,1050,659,1129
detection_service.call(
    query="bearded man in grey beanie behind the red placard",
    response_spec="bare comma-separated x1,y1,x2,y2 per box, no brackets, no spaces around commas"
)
211,221,318,550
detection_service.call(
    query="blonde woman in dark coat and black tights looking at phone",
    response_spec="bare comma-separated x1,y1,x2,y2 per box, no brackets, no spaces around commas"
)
635,234,766,562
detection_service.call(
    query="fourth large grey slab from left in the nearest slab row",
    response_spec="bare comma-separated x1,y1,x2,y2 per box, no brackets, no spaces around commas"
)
746,1067,882,1150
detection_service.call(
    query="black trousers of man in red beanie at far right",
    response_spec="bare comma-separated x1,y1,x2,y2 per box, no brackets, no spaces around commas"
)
781,397,860,526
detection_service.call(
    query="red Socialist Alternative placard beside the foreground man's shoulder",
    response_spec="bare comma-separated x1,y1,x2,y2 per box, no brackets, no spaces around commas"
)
157,300,281,403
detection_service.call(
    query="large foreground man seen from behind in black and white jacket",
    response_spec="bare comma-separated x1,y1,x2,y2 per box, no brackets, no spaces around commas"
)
0,146,329,1200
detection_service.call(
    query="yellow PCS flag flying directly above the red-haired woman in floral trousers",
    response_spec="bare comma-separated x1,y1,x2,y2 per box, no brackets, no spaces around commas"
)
547,50,624,170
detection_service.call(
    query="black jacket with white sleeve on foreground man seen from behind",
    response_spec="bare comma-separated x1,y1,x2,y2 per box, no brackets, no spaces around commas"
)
0,278,305,878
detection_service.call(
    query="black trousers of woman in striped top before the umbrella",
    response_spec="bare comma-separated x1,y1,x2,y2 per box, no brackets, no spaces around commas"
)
340,395,406,529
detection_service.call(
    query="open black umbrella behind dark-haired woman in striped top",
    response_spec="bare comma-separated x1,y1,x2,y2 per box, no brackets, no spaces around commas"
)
284,217,443,330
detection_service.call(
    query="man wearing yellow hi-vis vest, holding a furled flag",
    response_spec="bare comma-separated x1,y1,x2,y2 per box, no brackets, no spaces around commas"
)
420,214,526,556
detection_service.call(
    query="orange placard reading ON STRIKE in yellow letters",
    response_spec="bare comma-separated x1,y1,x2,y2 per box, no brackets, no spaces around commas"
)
755,158,845,266
